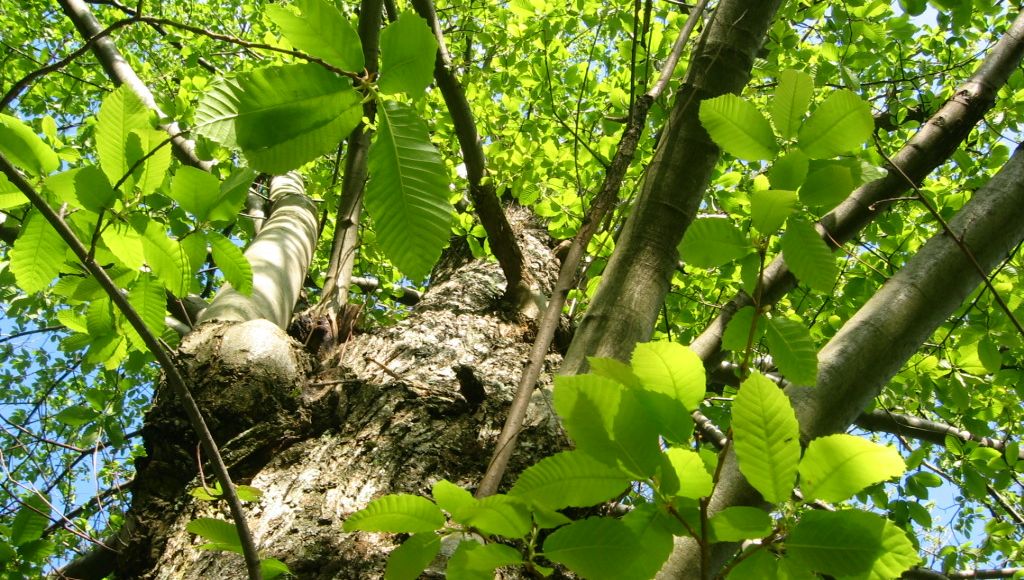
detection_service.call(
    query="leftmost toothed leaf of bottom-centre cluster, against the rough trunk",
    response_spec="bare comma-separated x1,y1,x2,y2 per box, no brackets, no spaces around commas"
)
342,494,444,534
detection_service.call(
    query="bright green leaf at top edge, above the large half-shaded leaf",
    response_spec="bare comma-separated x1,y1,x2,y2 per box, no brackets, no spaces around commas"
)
266,0,366,72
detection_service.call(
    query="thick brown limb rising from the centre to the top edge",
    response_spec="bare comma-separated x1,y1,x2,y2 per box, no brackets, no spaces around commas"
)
560,0,781,374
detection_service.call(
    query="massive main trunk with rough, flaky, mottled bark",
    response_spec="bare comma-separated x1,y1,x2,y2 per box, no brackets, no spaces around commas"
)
118,209,564,579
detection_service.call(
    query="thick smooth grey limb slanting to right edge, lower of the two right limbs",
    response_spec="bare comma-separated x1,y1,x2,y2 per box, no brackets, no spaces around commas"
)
662,149,1024,578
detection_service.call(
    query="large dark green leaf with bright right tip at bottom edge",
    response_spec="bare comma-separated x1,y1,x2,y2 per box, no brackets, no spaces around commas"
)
785,509,921,579
